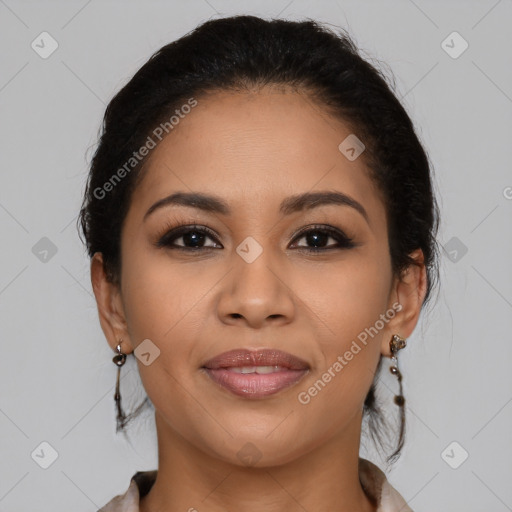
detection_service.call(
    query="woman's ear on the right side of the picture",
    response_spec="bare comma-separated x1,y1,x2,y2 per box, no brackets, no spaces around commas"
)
381,249,427,357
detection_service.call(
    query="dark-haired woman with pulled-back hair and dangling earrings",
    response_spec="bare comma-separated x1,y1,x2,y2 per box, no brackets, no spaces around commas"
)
80,16,438,512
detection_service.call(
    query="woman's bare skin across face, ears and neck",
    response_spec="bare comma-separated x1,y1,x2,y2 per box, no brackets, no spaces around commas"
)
91,86,426,512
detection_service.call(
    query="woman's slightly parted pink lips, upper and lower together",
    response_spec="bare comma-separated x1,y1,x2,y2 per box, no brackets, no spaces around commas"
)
203,349,309,399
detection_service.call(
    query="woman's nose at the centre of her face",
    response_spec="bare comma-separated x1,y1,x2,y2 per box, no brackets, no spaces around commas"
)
217,250,295,328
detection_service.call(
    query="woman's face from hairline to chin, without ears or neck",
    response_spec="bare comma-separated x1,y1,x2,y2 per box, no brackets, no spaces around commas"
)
95,89,416,465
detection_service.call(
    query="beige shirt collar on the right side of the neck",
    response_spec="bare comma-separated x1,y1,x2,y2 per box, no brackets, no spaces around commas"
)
359,457,413,512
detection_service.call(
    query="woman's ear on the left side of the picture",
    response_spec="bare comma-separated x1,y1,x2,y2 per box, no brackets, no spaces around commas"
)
91,252,133,354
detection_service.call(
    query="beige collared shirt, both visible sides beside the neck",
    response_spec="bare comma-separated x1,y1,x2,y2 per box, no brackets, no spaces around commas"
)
98,457,413,512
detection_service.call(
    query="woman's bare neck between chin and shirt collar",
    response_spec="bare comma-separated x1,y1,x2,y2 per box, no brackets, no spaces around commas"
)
139,412,376,512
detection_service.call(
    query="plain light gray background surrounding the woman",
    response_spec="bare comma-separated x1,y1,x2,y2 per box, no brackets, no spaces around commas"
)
0,0,512,512
